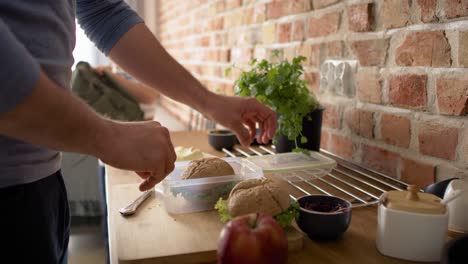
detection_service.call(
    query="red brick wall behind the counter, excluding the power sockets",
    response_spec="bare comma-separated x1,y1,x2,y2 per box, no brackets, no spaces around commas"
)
155,0,468,186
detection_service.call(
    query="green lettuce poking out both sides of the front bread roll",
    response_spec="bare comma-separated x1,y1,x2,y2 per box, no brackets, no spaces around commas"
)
215,198,299,228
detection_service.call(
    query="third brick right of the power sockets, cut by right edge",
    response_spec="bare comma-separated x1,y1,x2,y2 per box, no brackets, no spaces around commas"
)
436,77,468,116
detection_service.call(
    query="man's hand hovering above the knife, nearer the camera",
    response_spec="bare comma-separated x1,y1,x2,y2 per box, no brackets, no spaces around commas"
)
96,121,176,191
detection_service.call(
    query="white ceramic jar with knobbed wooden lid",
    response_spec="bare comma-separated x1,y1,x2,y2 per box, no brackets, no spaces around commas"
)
376,186,448,262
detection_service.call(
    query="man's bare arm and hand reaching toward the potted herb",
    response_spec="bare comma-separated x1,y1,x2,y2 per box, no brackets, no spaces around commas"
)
109,23,277,145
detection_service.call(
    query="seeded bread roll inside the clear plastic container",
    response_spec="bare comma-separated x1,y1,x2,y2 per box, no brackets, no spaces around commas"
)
182,158,235,180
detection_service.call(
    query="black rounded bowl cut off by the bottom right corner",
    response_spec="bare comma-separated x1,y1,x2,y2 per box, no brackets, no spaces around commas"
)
440,234,468,264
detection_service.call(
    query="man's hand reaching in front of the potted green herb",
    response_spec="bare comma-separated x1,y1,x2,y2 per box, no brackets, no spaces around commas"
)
206,95,277,146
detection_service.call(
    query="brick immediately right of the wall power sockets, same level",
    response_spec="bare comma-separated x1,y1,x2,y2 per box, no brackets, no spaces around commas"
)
356,69,382,104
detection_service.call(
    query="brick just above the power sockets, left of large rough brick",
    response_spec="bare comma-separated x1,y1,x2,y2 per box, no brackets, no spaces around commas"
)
351,39,388,66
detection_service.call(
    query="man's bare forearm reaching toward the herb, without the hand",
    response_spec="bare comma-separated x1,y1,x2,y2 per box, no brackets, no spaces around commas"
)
109,24,216,113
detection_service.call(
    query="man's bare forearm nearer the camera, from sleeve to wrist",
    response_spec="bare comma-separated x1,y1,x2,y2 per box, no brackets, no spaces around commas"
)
0,72,110,155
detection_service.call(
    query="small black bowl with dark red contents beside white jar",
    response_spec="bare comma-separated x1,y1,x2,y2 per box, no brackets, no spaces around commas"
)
296,195,352,240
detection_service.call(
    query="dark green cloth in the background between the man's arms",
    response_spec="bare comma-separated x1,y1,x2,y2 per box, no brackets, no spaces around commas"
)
71,62,144,121
